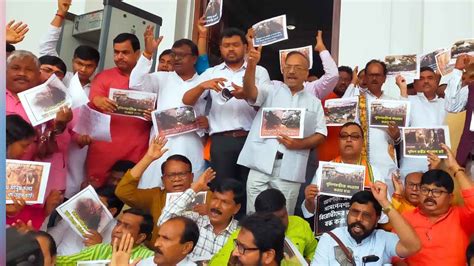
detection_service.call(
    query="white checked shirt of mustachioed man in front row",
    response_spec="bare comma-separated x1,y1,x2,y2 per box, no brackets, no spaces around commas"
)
158,189,238,259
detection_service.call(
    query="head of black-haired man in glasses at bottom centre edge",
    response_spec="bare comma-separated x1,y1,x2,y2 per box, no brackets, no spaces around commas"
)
230,213,285,266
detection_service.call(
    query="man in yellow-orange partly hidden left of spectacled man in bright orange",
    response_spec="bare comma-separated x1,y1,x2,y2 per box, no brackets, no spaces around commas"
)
392,172,423,213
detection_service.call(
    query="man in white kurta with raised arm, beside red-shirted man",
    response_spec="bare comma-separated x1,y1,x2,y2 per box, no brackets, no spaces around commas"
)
130,25,208,188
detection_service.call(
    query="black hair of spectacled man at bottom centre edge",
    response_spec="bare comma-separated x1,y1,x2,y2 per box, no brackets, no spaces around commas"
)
240,213,286,264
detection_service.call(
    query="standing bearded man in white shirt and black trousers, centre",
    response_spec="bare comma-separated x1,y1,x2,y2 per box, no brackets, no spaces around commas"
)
183,28,270,214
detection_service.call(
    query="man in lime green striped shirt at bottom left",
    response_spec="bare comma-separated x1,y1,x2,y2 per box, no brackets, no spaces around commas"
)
56,208,153,265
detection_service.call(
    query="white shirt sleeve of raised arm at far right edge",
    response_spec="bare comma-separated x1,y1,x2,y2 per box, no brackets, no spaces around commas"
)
444,68,469,112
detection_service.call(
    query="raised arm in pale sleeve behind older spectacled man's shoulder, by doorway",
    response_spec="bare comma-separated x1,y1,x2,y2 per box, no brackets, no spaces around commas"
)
305,31,339,99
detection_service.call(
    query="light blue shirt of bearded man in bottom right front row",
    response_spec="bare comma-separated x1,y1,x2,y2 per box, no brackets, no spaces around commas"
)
311,226,400,266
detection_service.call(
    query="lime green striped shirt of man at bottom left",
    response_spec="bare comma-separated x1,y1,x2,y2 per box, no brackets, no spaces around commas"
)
56,243,154,266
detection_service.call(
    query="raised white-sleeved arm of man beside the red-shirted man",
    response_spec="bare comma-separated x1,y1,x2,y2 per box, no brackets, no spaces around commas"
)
129,25,163,93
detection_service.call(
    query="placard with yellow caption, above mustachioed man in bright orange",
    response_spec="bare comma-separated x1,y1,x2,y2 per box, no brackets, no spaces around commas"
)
402,126,450,158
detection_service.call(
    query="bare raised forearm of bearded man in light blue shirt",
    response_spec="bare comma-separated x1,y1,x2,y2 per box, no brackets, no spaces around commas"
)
370,181,421,258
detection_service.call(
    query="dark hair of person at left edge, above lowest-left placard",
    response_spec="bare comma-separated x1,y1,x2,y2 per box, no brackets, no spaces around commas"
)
5,115,36,147
